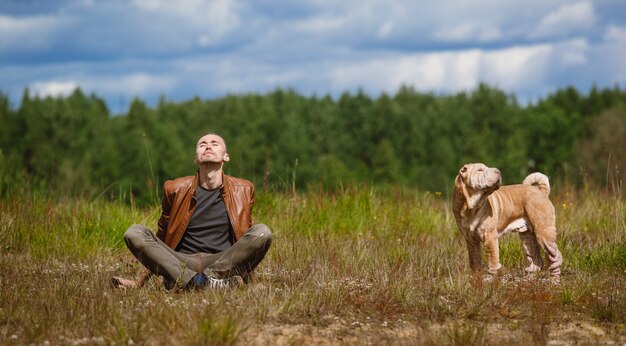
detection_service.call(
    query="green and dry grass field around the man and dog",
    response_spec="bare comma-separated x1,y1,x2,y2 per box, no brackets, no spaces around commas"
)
0,186,626,345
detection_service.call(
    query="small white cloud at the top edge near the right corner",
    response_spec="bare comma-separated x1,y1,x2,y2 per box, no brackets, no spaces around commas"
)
530,1,596,38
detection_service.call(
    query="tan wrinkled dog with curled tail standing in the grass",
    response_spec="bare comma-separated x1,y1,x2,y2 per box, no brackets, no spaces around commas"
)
452,163,563,282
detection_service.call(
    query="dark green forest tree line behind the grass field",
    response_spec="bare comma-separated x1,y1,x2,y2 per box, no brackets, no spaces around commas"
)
0,84,626,201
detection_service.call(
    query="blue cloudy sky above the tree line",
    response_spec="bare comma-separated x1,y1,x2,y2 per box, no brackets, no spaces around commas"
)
0,0,626,113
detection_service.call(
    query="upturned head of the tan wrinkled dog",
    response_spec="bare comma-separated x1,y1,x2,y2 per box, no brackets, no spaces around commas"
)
455,163,502,209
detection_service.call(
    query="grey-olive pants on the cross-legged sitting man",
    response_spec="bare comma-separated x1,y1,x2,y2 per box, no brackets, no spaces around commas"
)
124,224,272,289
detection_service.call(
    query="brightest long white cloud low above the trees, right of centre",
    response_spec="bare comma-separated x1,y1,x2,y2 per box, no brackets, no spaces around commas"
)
330,45,553,93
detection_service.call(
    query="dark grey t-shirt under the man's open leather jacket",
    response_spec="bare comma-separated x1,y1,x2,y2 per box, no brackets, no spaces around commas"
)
176,185,235,254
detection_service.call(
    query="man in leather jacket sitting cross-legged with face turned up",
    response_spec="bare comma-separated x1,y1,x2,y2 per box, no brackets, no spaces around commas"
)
112,133,272,289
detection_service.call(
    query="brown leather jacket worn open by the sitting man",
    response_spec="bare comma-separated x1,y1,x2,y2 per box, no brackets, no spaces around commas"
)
156,174,254,249
